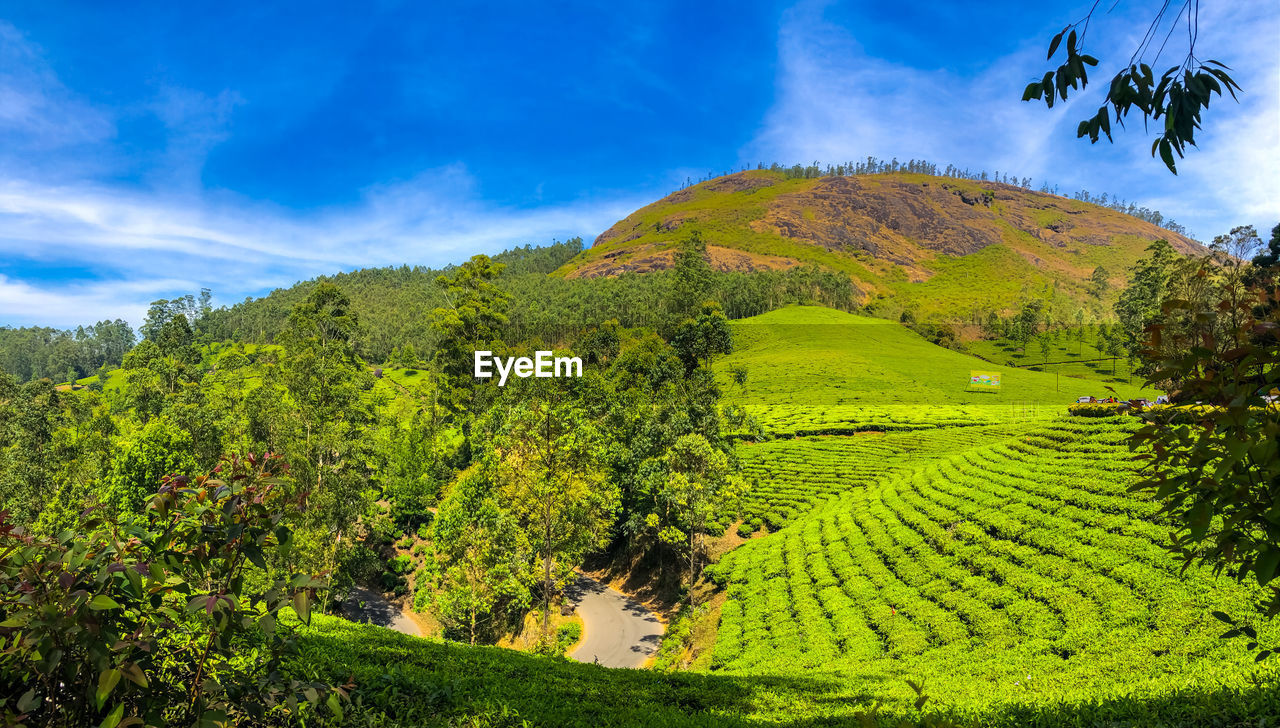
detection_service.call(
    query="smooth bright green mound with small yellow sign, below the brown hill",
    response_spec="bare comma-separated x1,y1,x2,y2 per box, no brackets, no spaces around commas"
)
716,306,1155,434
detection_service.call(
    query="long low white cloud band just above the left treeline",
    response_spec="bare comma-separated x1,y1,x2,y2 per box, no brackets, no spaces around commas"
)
0,166,644,326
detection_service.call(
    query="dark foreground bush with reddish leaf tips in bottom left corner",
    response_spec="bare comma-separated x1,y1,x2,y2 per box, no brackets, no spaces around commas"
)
0,454,344,728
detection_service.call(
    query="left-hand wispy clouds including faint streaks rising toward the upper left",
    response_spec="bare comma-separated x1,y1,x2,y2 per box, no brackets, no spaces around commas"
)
0,22,645,326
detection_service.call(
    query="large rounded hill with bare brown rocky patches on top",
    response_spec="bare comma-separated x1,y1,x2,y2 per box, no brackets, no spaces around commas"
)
558,170,1202,320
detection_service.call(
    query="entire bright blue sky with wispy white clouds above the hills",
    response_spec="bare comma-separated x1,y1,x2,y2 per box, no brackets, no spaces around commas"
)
0,0,1280,326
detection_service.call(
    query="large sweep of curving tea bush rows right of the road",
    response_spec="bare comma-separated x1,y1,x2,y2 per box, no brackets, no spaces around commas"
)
713,421,1256,701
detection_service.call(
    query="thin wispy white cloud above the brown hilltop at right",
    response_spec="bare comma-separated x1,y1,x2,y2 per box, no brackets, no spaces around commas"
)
742,3,1280,237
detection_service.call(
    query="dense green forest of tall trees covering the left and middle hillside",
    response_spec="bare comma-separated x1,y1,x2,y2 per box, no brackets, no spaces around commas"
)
0,231,768,723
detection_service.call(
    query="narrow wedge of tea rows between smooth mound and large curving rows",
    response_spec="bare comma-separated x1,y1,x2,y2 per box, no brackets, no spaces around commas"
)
737,425,1020,531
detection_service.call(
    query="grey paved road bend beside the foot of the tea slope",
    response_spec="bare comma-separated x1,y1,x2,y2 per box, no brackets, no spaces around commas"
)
564,574,663,668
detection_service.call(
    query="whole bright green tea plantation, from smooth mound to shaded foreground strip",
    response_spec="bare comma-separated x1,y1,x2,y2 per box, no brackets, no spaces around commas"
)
294,307,1280,728
